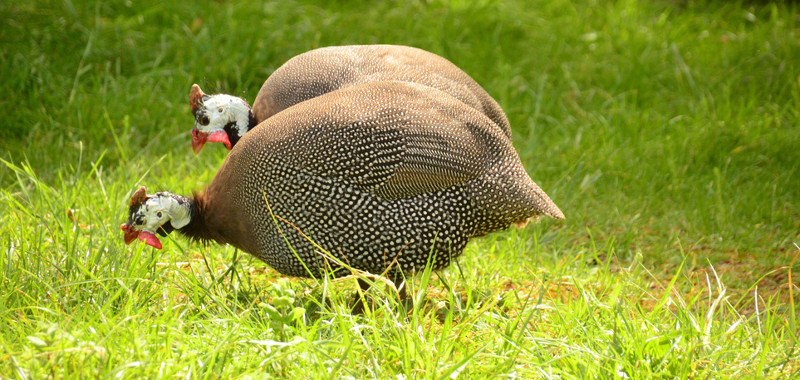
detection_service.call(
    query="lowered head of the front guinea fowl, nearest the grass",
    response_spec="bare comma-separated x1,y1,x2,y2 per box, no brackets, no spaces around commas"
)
120,186,191,249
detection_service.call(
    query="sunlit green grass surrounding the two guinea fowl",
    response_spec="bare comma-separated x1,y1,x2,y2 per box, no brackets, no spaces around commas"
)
0,0,800,378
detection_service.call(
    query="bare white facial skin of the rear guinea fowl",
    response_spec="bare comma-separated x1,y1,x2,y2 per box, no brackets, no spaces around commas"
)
196,94,250,137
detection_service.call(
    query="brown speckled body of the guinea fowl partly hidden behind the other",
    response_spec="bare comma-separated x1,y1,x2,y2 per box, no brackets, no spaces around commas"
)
253,45,511,138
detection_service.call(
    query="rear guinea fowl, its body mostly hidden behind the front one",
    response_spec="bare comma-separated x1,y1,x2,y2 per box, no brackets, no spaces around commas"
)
189,45,511,153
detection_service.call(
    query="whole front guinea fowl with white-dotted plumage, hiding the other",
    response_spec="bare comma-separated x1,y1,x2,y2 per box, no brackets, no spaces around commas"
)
122,82,564,302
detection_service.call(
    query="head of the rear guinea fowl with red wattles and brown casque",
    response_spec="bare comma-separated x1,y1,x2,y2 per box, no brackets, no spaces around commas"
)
189,84,256,154
